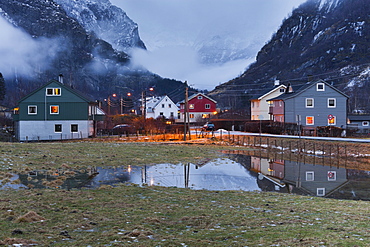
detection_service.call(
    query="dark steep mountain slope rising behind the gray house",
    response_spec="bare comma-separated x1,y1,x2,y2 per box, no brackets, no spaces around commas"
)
210,0,370,112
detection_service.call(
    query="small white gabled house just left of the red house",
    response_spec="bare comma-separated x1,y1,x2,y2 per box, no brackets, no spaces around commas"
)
146,95,178,119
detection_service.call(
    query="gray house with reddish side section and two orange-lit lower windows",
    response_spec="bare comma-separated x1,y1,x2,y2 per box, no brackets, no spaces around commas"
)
269,80,348,128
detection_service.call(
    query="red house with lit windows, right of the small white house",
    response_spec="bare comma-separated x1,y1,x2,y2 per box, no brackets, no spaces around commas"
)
178,93,217,123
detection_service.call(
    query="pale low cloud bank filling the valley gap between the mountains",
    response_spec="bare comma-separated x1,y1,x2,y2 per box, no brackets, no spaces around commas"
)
131,46,254,90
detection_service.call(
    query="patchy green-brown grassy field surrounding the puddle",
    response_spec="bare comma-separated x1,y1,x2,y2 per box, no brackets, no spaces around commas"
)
0,142,370,246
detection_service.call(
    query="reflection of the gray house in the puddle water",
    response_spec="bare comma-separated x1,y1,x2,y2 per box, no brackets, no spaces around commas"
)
283,161,348,196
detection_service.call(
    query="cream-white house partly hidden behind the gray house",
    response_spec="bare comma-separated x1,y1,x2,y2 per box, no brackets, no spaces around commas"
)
251,84,286,120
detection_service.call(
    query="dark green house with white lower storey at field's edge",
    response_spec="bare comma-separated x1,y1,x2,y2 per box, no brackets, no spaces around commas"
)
13,76,105,141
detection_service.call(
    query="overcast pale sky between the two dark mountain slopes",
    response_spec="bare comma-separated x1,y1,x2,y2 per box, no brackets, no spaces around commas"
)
111,0,306,90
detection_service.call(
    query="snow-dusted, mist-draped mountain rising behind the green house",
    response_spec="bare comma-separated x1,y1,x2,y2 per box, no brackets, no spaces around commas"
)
0,0,185,106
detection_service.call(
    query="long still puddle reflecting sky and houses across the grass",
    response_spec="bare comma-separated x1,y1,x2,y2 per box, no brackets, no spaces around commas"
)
0,154,370,200
